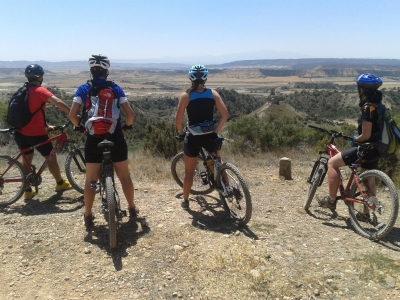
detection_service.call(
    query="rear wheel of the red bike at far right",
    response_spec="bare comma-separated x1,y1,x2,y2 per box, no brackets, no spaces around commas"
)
346,170,399,240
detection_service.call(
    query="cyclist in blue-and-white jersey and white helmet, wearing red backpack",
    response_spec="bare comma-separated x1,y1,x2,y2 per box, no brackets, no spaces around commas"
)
69,54,139,231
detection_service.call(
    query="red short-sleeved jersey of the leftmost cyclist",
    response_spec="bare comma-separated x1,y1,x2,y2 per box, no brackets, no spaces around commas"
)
18,86,53,136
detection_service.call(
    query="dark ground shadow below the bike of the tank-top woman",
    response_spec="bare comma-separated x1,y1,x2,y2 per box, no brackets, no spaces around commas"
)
176,194,258,240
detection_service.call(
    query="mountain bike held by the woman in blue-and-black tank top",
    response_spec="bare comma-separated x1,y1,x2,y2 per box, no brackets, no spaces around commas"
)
171,137,252,225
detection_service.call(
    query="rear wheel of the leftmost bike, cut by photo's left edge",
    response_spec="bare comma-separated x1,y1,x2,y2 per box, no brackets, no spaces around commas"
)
0,155,26,207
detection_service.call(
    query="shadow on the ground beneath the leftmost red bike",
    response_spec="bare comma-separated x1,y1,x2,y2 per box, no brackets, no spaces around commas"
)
0,193,84,216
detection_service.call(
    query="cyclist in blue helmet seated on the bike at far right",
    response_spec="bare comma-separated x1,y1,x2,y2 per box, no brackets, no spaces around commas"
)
317,73,382,221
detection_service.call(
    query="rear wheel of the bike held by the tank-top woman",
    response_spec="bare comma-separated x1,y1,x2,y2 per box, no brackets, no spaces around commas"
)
217,163,253,225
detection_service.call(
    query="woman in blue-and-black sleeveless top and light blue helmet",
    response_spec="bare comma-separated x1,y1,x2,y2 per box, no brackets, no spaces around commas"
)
175,65,229,209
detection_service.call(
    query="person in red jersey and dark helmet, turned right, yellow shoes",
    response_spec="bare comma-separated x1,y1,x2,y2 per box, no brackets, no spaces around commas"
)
14,64,72,200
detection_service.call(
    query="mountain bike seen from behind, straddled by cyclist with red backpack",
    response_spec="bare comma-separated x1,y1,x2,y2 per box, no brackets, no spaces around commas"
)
90,139,127,249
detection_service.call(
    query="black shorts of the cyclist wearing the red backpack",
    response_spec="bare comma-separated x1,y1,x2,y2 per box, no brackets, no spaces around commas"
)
85,130,128,163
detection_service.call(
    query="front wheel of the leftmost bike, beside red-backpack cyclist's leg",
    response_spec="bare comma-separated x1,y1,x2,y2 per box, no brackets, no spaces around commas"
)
65,147,86,194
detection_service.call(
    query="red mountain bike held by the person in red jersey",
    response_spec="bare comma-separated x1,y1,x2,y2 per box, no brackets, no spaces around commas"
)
0,123,85,207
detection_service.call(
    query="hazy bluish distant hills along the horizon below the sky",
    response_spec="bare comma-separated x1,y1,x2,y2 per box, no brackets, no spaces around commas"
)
0,58,400,77
